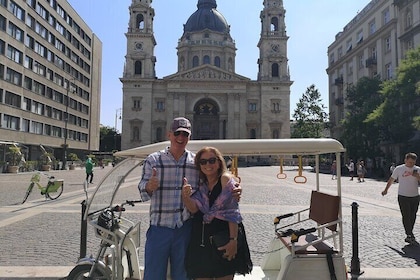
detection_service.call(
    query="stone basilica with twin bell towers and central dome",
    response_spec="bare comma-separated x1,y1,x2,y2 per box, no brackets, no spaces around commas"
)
120,0,292,149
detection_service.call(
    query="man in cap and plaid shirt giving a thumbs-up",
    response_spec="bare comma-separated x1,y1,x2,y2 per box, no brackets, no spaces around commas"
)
139,117,198,280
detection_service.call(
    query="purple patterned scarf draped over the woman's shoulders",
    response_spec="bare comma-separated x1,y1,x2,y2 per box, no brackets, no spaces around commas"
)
192,178,242,223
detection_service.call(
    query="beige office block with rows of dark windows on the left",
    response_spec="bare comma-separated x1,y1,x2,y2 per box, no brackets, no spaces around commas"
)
0,0,102,167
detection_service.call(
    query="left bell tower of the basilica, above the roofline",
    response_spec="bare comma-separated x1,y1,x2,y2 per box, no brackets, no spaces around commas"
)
124,0,156,79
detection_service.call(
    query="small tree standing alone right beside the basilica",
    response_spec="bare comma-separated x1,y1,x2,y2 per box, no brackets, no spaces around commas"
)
291,85,328,138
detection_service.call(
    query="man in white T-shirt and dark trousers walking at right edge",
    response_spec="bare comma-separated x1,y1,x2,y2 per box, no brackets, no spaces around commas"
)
382,153,420,244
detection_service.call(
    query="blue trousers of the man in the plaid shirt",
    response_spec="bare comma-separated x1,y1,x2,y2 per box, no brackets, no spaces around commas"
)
144,220,192,280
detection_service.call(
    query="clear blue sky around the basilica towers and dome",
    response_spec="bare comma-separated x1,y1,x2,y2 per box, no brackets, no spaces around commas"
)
68,0,370,131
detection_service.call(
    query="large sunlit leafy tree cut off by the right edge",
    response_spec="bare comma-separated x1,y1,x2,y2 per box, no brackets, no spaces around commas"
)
366,48,420,149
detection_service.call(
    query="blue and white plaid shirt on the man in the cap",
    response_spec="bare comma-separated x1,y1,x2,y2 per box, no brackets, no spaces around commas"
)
138,148,198,228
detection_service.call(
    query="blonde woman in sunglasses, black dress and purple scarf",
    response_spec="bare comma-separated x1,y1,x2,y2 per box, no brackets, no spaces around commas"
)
182,147,252,280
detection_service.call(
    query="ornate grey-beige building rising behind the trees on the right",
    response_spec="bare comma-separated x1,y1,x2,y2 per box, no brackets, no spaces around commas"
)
327,0,420,139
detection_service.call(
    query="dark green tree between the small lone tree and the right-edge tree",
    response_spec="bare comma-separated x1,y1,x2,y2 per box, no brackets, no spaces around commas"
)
340,77,383,159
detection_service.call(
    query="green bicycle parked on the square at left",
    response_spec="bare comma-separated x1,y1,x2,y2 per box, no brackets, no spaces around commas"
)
22,172,64,204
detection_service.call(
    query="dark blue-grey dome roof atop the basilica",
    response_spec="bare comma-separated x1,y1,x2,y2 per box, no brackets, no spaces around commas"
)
184,0,229,32
